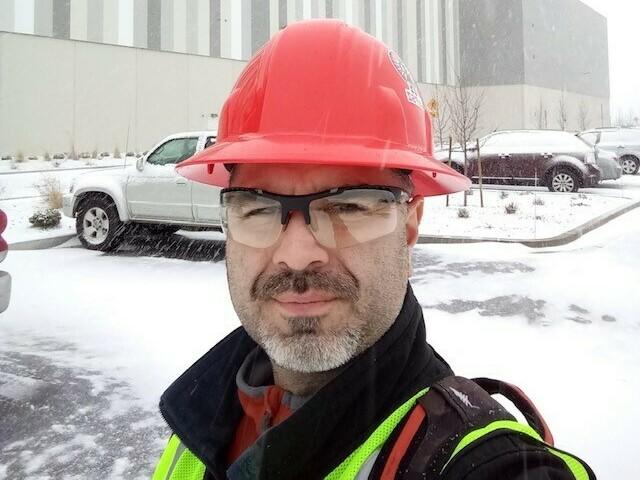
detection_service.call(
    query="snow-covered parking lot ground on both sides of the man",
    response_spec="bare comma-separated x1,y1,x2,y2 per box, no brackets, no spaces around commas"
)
0,210,640,480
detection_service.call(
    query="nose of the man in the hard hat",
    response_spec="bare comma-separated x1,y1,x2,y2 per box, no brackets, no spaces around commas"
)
273,212,329,271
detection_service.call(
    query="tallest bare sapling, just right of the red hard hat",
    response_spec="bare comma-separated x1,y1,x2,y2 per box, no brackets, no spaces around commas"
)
445,77,485,207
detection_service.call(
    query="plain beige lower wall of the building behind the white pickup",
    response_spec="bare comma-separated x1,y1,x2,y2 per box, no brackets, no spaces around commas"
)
0,32,245,155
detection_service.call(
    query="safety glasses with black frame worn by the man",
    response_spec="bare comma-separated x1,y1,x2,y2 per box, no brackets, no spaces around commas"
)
220,186,409,248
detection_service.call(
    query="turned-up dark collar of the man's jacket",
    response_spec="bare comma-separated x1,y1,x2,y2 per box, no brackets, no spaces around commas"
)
160,286,452,480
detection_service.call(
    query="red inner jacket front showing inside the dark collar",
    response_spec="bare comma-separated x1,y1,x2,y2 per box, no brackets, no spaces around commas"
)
227,385,292,465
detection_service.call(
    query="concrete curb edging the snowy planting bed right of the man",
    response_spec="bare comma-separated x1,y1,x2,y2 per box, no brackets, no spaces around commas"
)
418,201,640,248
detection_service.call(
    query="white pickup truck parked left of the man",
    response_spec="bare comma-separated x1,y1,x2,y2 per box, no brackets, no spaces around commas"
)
63,131,220,251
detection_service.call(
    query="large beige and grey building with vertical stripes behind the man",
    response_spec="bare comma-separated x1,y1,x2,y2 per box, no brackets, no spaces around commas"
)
0,0,609,155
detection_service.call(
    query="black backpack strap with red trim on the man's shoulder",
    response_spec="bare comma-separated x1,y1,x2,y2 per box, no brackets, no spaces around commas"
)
380,376,553,480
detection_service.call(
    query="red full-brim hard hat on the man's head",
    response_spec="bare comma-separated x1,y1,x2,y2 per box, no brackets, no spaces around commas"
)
177,20,470,196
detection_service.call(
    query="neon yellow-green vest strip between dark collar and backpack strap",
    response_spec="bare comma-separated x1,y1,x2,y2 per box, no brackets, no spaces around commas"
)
325,388,429,480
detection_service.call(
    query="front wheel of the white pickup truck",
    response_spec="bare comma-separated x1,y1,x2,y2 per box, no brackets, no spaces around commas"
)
76,196,125,252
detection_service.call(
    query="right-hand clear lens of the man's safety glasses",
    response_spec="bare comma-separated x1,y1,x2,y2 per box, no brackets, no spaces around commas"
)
309,189,398,248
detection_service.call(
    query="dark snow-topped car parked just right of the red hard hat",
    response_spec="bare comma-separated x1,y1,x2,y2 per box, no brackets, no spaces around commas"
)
435,130,601,192
